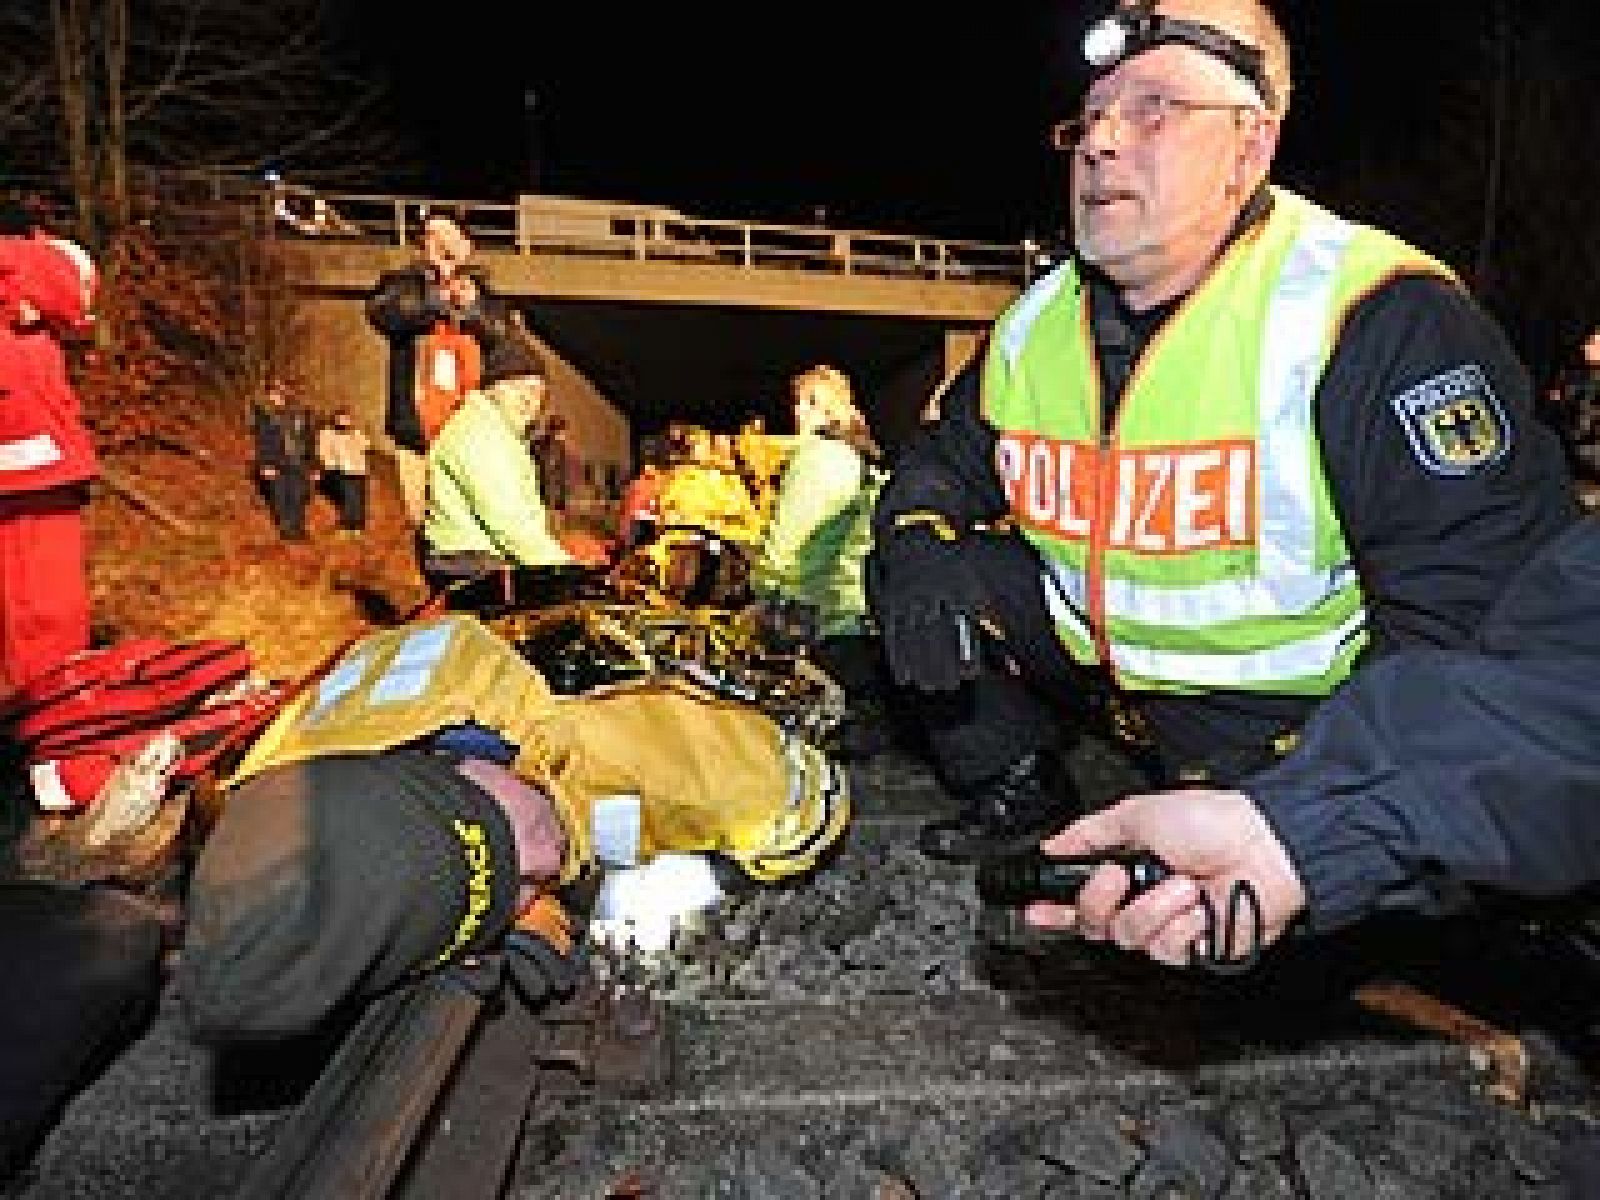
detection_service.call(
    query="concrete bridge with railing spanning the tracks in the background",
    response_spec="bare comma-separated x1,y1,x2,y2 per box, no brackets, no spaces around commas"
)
258,175,1032,499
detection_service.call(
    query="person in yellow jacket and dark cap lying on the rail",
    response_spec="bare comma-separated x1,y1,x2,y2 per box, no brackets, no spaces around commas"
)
178,613,850,1042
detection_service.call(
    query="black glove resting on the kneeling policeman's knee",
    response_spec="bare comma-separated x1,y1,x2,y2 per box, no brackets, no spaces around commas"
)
870,518,992,691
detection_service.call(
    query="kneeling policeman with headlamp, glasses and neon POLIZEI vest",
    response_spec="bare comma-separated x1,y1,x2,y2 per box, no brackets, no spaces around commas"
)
869,0,1578,861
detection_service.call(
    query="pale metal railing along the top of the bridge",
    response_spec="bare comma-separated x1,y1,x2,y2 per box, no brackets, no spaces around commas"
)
254,182,1032,285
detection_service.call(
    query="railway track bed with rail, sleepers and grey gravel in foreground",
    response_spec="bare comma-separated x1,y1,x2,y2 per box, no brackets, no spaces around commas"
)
18,742,1600,1200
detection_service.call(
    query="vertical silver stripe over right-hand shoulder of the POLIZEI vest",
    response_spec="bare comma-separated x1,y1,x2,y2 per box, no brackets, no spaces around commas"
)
1256,198,1355,579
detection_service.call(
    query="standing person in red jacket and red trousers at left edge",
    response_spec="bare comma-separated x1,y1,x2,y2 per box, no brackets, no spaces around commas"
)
0,232,98,696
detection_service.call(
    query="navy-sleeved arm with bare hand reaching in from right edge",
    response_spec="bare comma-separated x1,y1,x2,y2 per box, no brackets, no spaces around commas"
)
1029,508,1600,965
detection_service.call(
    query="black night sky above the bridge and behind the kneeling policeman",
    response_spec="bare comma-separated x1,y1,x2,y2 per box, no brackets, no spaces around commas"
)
321,0,1600,387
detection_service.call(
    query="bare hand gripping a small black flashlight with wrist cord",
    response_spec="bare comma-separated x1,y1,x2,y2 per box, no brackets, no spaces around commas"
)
1027,789,1306,966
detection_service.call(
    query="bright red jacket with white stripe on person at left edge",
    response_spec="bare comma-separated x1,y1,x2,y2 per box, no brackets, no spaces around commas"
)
0,237,96,496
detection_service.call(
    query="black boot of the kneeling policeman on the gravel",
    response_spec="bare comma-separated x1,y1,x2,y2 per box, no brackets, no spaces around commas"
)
917,750,1083,862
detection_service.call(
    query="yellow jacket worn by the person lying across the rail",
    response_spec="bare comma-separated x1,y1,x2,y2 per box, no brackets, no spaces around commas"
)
226,613,850,882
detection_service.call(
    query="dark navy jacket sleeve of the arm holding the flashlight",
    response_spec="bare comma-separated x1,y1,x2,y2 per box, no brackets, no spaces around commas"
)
1245,518,1600,931
